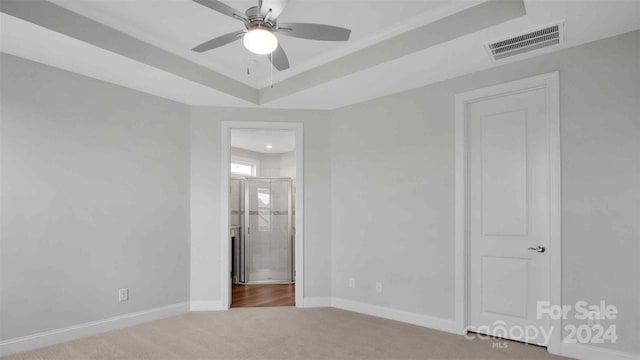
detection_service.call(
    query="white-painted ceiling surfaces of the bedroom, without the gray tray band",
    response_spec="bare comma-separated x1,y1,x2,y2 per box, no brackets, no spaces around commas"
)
0,0,640,109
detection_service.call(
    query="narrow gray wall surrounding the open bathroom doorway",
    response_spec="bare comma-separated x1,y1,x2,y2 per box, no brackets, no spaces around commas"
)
191,107,331,301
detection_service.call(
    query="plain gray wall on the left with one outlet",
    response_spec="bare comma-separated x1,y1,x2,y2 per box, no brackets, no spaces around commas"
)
0,54,189,340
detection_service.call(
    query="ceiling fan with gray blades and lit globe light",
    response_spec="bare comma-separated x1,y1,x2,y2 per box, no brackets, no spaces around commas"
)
192,0,351,71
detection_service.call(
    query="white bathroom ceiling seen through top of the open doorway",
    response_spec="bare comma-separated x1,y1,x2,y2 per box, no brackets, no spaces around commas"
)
231,130,296,154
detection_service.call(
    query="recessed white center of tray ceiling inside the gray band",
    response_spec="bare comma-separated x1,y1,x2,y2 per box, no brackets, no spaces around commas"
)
47,0,451,88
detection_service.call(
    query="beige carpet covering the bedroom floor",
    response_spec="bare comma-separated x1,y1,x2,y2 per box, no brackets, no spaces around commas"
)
3,307,560,360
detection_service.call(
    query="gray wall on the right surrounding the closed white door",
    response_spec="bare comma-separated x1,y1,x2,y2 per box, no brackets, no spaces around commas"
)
331,32,640,352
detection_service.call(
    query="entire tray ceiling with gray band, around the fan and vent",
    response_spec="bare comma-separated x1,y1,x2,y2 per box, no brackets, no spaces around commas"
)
0,0,640,109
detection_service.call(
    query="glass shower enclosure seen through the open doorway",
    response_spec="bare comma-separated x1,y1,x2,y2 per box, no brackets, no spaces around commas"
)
230,177,294,284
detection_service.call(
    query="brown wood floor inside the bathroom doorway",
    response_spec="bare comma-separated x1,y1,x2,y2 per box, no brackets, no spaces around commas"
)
231,284,296,307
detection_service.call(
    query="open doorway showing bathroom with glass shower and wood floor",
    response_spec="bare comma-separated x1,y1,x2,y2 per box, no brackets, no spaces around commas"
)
226,128,301,307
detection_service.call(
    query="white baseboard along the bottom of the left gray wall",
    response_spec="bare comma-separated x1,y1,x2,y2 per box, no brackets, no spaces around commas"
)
0,302,189,356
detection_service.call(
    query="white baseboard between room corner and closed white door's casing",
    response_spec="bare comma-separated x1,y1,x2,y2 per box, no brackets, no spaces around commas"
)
331,298,461,335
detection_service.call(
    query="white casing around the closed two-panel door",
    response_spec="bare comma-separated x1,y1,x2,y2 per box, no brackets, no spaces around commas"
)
455,71,562,354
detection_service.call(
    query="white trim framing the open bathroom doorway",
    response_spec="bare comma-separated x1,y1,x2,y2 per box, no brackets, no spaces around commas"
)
220,121,304,310
